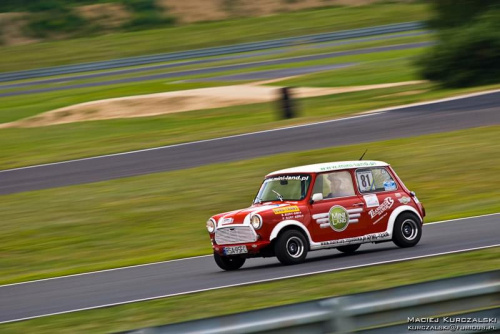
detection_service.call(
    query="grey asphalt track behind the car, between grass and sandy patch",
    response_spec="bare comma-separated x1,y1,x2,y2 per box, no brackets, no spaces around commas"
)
0,92,500,194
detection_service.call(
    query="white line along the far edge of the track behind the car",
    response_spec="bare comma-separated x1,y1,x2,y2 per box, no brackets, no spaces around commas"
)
0,89,500,173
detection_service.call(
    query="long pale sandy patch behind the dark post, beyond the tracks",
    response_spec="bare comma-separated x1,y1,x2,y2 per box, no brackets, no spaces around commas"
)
0,81,422,128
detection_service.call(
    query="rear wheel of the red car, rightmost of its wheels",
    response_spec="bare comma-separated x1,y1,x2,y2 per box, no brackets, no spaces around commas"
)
392,212,422,248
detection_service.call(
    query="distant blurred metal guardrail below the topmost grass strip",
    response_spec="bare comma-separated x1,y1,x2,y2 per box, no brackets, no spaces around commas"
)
0,22,424,82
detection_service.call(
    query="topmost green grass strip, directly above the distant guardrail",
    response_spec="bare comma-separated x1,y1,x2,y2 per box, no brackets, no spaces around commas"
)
0,3,429,72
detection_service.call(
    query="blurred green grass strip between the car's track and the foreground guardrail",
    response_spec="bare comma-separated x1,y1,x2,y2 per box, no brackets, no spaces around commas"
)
0,247,500,334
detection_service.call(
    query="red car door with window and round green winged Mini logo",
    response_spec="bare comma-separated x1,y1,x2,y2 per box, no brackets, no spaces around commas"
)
309,170,366,242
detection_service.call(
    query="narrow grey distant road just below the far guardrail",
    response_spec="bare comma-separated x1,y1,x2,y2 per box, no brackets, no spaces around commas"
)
0,42,432,97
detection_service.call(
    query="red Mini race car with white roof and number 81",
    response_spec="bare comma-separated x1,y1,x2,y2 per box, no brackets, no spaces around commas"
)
206,161,425,270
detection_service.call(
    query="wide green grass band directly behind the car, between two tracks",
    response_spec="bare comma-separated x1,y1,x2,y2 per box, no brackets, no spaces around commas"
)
0,126,500,284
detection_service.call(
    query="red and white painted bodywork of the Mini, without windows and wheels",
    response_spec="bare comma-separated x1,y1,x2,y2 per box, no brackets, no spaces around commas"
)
205,161,425,257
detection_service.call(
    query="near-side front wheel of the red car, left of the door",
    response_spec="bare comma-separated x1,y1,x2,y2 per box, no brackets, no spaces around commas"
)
274,230,309,265
